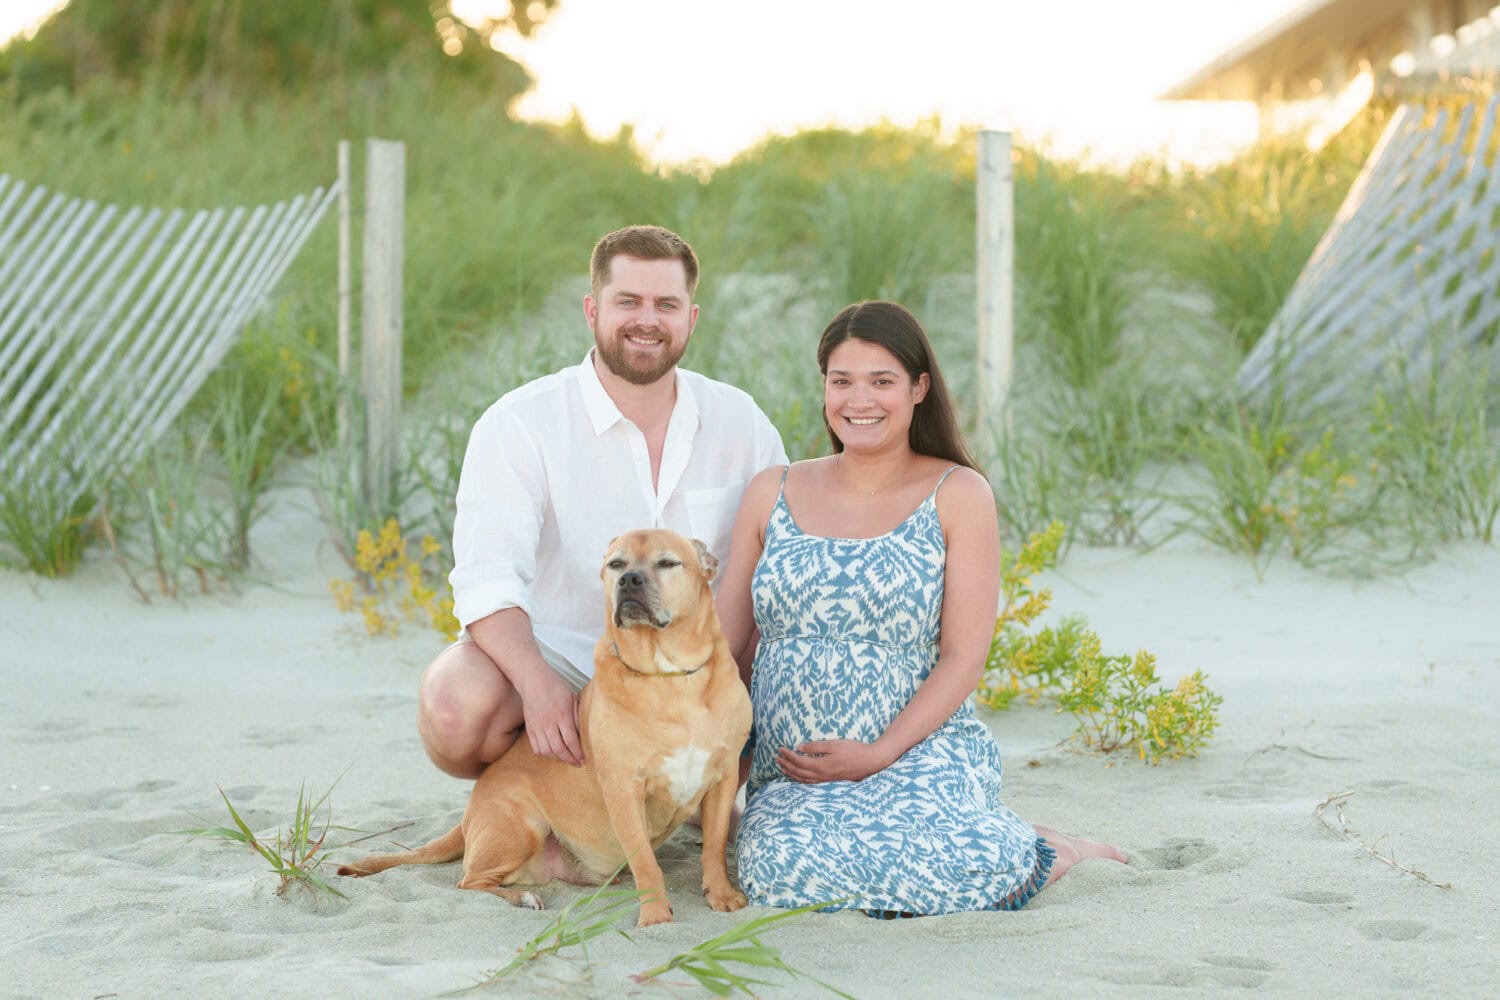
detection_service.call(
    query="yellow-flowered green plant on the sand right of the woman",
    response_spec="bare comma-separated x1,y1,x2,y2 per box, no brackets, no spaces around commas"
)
977,522,1223,765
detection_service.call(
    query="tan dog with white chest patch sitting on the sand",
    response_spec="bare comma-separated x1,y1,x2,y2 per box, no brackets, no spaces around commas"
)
339,531,750,927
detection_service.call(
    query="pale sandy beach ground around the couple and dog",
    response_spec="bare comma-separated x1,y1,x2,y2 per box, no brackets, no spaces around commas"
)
0,494,1500,999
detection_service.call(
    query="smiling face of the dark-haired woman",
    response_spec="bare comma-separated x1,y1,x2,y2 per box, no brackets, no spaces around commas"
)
824,337,929,451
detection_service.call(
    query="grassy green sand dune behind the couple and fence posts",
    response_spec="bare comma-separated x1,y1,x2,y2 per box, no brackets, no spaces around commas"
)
0,75,1500,588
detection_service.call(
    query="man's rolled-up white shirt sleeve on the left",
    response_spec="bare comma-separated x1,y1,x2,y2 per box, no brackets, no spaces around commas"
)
449,400,546,628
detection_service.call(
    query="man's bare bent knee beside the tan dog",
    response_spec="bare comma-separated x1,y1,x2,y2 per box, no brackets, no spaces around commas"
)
417,642,525,778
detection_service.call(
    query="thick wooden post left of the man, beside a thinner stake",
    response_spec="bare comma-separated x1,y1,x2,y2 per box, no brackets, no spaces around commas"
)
360,139,407,514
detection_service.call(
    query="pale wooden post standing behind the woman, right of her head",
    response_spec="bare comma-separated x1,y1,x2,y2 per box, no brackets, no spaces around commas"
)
975,130,1016,433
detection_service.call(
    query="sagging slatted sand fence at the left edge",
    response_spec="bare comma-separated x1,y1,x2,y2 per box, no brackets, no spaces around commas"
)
0,175,338,501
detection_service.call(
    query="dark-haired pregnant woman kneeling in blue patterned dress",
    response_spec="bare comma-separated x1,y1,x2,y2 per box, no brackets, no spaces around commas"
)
719,301,1125,916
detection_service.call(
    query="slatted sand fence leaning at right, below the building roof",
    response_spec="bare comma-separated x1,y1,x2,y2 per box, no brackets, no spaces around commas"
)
1239,96,1500,402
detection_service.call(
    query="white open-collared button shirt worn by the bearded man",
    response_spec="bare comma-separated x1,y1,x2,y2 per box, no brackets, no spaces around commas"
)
449,351,786,676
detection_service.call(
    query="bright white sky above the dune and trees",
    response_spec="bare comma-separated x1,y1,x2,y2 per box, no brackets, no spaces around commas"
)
0,0,1307,162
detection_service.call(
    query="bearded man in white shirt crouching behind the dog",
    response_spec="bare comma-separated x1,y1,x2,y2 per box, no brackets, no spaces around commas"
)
417,226,786,778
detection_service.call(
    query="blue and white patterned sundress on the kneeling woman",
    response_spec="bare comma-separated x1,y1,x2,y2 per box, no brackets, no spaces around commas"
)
735,469,1053,916
